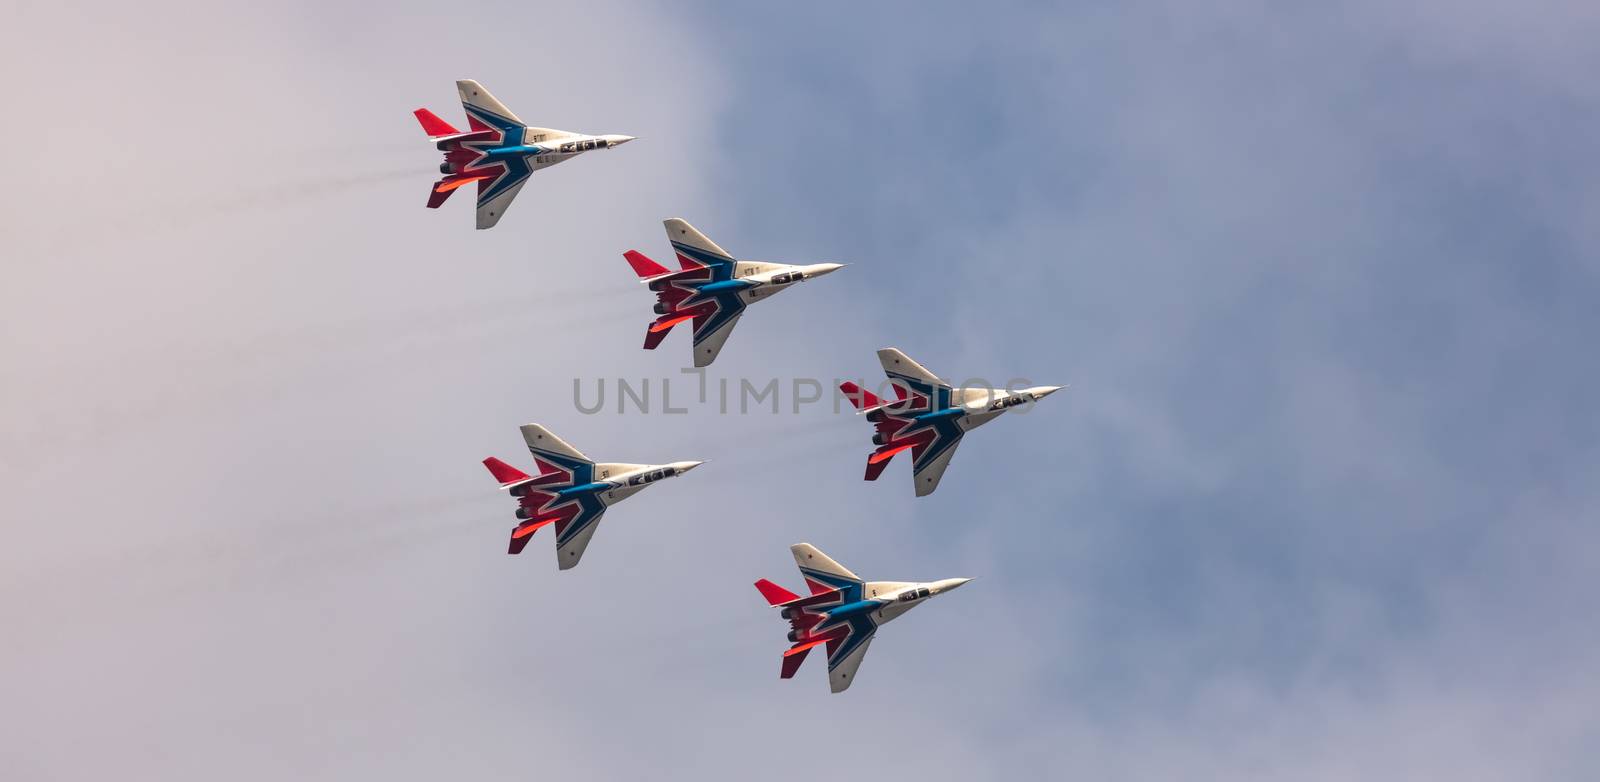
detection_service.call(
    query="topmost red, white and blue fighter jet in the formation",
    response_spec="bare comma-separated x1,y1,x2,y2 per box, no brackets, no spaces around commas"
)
414,78,634,229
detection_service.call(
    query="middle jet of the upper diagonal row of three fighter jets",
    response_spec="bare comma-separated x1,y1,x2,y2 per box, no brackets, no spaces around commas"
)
622,217,845,366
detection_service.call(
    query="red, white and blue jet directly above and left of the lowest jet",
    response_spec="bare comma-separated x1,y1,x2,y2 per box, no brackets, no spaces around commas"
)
483,424,706,571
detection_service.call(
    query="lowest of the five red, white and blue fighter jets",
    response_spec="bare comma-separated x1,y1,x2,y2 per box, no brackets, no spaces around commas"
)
755,544,973,692
